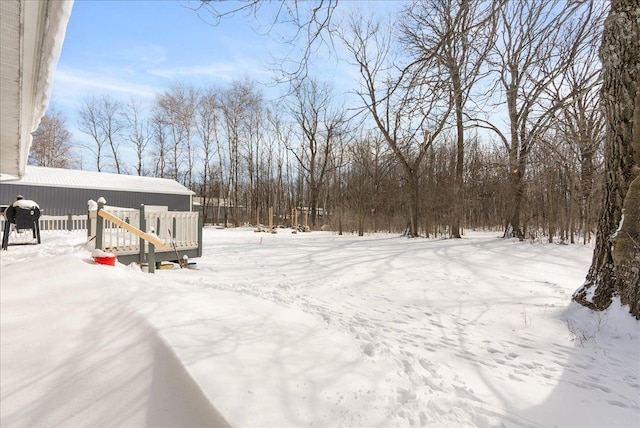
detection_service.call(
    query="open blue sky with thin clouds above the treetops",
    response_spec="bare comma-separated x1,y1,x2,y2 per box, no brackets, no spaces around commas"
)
51,0,399,113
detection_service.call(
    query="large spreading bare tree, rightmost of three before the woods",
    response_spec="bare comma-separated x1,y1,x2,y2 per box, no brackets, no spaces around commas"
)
483,0,602,239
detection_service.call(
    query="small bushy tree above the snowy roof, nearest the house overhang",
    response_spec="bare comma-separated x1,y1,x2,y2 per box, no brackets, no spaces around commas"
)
29,109,75,168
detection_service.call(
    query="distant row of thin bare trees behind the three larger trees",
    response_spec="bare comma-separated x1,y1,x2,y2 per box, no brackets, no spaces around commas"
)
32,87,602,241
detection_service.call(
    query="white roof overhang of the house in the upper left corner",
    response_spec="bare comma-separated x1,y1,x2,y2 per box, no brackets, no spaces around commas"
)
0,0,73,178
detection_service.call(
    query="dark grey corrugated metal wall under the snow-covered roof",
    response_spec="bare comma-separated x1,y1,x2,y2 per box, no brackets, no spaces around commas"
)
0,182,191,215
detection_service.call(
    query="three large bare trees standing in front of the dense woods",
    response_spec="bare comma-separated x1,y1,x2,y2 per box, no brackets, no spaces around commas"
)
343,0,604,237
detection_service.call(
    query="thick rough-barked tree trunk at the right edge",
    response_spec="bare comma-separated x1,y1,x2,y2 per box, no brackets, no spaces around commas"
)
573,0,640,319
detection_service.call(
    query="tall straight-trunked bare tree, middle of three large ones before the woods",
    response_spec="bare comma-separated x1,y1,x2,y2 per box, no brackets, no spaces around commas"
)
401,0,501,238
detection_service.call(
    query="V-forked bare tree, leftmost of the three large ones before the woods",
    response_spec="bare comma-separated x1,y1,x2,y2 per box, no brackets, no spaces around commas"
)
344,16,453,237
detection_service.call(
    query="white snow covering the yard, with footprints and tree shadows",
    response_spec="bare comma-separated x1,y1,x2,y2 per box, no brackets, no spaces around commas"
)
0,228,640,427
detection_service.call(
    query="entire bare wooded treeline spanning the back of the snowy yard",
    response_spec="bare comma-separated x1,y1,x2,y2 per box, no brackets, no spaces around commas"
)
30,0,606,242
